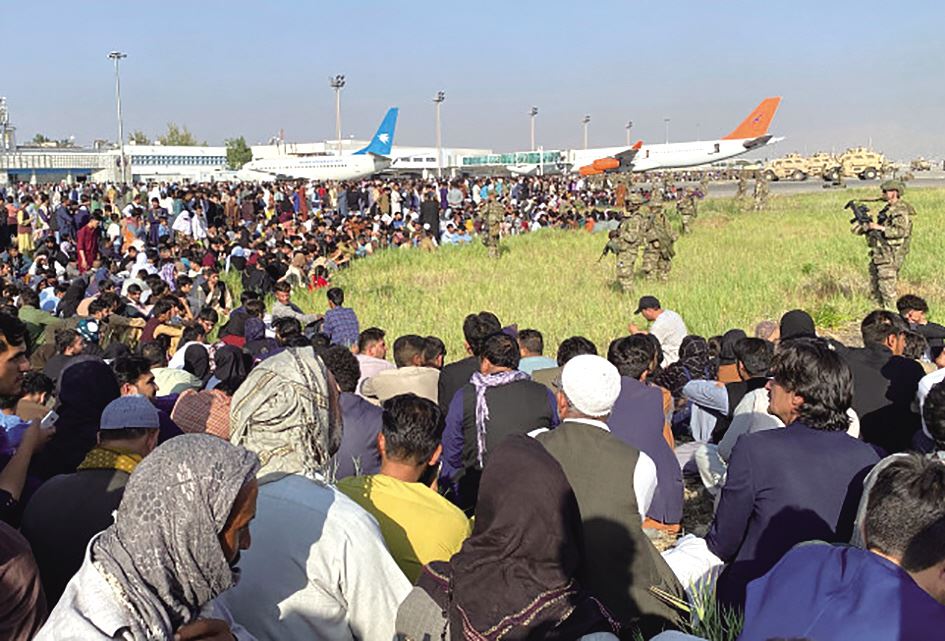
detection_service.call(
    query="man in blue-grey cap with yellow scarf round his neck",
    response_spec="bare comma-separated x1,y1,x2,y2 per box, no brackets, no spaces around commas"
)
23,396,160,608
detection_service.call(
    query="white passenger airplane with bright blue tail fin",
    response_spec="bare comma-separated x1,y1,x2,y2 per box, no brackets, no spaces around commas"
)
238,107,397,180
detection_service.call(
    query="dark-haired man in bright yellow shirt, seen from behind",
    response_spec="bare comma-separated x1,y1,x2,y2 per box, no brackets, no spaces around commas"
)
338,394,471,583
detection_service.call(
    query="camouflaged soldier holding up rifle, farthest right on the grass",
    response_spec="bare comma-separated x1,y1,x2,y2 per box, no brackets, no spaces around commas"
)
853,180,915,309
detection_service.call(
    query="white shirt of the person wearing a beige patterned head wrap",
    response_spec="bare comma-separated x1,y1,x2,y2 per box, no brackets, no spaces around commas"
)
222,474,411,641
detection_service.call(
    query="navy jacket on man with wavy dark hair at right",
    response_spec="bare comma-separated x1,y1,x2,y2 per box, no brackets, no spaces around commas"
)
706,422,879,606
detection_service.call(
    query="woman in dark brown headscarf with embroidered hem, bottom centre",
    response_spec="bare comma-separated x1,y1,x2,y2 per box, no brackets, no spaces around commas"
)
397,436,619,641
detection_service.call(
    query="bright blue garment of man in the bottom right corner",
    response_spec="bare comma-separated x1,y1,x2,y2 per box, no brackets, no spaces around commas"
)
738,544,945,641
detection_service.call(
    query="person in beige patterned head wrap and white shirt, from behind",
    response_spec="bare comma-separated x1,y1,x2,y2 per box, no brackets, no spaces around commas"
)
224,347,410,641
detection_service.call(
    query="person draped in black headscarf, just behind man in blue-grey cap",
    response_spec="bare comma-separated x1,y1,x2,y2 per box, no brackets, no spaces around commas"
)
30,356,120,481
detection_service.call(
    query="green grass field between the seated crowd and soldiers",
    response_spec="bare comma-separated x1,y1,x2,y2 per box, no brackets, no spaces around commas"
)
240,189,945,360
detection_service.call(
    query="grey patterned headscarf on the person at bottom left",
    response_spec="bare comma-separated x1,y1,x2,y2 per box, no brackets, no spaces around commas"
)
91,434,259,639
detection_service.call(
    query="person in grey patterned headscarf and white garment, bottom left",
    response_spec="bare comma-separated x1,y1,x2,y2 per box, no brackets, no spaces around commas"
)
36,434,259,641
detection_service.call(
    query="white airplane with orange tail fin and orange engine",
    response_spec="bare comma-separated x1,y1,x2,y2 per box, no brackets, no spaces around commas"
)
568,96,784,176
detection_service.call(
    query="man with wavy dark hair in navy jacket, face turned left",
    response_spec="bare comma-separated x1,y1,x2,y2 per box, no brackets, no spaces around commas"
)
704,338,879,606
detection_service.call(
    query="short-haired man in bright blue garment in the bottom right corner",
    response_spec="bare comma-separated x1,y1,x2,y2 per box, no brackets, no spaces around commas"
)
738,454,945,641
